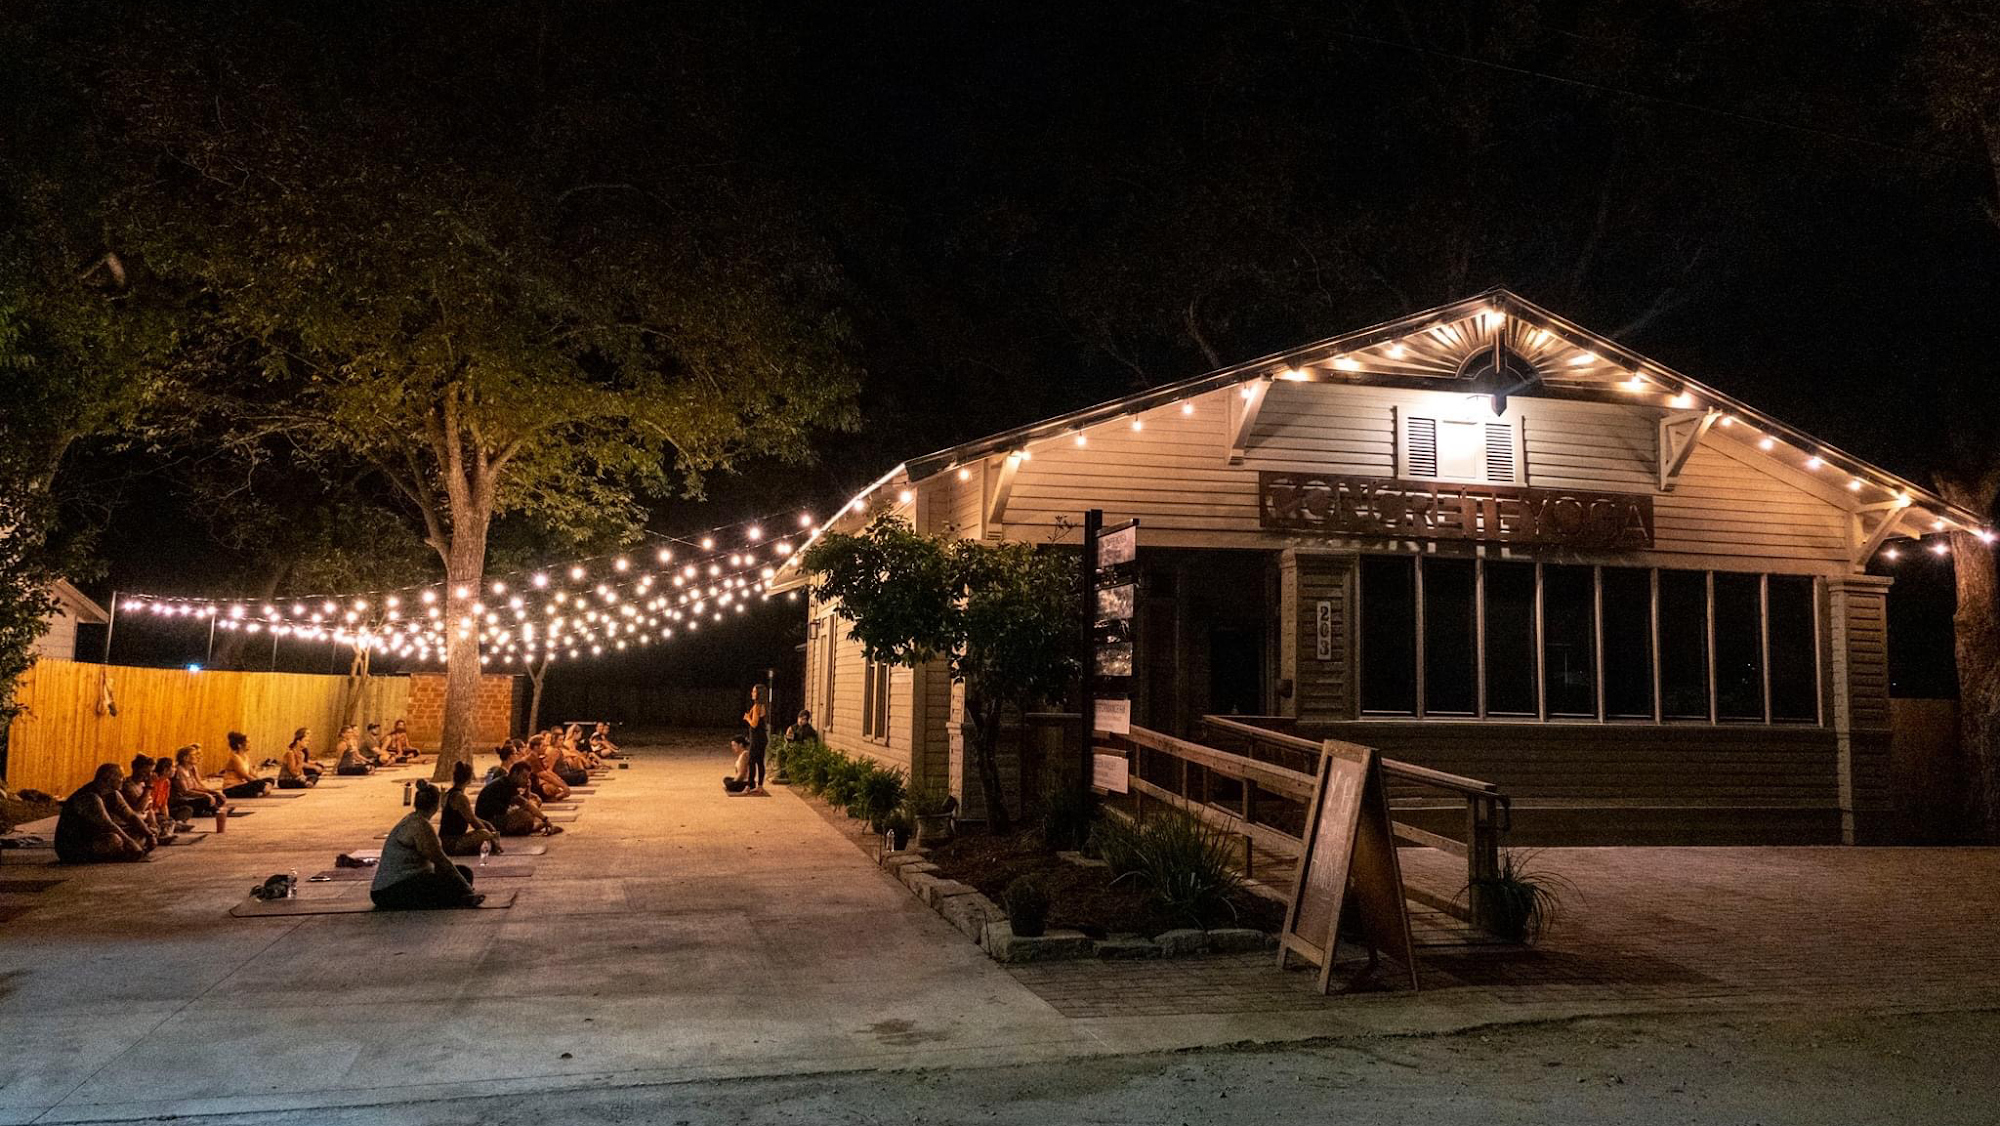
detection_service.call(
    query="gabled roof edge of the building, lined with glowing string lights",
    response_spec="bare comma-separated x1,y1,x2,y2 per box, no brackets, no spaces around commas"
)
786,288,1992,576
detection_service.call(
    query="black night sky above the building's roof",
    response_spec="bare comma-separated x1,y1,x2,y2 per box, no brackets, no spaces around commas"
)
66,2,2000,696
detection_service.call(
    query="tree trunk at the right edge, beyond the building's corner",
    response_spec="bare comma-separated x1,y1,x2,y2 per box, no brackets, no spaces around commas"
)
1938,470,2000,840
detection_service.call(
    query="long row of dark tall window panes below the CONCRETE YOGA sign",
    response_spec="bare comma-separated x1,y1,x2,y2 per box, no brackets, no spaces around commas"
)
1358,556,1820,724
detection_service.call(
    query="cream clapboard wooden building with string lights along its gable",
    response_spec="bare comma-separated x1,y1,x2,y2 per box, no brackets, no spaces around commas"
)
778,290,1992,842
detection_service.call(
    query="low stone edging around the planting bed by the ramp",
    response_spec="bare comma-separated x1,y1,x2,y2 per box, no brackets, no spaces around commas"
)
876,850,1276,962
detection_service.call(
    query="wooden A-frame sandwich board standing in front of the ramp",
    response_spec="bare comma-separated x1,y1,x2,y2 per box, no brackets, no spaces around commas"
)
1278,740,1418,994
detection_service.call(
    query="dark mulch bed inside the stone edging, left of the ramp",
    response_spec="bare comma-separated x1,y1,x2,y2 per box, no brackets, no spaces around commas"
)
928,830,1284,938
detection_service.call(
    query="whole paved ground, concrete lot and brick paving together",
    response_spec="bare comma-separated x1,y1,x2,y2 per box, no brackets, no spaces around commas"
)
0,736,2000,1124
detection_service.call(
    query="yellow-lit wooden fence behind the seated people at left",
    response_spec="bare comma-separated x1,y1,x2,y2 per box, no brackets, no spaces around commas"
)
6,660,410,796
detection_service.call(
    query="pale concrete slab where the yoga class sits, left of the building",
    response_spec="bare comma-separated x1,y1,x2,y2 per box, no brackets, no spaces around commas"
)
0,740,1092,1122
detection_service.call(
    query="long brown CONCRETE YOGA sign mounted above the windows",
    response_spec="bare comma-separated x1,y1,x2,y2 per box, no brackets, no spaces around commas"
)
1258,470,1652,548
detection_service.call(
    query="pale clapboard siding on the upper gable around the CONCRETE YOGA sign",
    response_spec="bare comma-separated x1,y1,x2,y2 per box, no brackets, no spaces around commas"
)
980,382,1848,570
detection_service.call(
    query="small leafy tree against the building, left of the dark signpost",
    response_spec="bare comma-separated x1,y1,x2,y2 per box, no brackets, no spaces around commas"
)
800,514,1080,832
